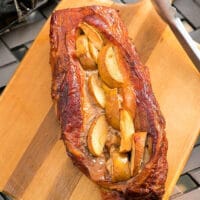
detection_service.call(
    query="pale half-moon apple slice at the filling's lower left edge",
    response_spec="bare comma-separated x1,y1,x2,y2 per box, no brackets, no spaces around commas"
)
88,115,108,156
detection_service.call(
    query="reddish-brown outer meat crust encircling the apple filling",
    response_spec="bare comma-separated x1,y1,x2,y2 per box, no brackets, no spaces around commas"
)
50,6,168,200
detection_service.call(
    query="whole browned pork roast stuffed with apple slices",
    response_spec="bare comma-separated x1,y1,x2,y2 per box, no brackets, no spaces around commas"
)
50,6,168,200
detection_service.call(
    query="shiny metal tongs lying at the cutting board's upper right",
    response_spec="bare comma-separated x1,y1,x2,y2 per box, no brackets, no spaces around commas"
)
151,0,200,71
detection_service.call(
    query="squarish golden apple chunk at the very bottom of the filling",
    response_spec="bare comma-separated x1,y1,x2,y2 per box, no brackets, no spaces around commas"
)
111,151,131,182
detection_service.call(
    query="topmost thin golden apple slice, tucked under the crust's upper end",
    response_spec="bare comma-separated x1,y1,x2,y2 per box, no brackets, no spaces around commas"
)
79,22,103,50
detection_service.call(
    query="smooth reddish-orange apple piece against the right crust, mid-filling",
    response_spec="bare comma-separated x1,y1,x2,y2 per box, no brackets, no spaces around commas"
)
121,85,136,119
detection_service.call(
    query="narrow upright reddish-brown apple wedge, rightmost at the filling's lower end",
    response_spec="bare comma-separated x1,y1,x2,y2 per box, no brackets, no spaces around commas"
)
132,132,147,175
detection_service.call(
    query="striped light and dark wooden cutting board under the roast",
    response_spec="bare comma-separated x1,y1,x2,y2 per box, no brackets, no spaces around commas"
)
0,0,200,200
